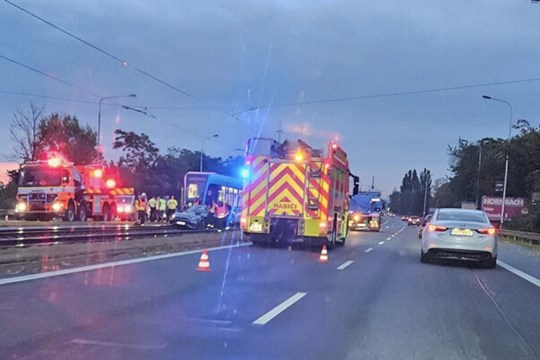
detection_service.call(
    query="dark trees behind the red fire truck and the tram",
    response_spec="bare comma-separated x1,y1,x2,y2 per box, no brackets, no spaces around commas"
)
0,103,243,209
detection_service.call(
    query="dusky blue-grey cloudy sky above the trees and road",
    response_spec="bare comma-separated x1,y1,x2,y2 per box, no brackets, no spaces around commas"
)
0,0,540,195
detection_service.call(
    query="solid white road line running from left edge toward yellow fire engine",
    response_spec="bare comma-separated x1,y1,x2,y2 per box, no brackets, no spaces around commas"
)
0,242,251,285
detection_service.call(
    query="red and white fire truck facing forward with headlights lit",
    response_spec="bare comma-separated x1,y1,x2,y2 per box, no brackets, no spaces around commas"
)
15,151,134,221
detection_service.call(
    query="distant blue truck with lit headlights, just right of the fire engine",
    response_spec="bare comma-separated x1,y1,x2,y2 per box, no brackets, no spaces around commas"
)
349,190,385,231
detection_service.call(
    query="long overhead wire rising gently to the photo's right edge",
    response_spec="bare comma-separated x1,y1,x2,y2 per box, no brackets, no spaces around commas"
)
258,77,540,108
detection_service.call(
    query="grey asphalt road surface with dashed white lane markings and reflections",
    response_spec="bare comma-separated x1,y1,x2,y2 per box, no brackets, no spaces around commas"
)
0,218,540,359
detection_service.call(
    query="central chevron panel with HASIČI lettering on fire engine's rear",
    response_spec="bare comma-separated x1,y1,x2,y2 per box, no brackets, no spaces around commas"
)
267,163,306,216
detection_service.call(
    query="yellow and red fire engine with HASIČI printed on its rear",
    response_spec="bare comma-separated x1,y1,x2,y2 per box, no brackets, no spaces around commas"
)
240,138,350,248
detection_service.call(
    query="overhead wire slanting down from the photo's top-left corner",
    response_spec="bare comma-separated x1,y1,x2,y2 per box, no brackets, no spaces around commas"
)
4,0,234,118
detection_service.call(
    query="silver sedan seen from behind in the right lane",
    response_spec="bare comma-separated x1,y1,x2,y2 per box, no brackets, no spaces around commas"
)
420,209,499,268
